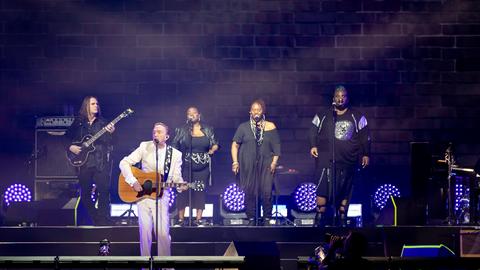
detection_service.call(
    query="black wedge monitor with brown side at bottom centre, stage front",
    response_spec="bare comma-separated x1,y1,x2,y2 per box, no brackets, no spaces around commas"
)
223,241,280,270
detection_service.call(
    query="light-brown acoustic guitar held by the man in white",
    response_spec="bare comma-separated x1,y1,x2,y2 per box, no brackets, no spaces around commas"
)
118,167,205,203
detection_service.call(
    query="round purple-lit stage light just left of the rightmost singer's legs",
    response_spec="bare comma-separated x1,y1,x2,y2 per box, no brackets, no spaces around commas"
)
291,183,317,226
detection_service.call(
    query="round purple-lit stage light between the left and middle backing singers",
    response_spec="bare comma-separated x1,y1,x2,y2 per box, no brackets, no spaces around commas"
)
220,184,247,225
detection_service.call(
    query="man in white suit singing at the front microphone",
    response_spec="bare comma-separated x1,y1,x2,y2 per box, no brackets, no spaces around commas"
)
120,122,186,256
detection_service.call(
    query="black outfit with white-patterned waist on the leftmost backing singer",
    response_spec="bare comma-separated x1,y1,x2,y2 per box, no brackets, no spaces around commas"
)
172,124,218,210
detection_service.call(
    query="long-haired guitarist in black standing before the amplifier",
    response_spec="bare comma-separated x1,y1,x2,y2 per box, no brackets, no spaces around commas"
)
66,96,115,225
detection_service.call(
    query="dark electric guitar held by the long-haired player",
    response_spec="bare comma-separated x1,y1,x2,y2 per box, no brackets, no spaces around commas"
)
67,109,133,167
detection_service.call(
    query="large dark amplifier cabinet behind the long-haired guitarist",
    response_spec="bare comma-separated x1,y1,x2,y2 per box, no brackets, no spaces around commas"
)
35,128,77,178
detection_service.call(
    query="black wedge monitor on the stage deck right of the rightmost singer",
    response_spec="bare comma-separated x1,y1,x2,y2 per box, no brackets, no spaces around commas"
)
375,197,426,226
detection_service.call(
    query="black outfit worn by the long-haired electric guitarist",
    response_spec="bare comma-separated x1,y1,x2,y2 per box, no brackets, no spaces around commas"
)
66,117,112,225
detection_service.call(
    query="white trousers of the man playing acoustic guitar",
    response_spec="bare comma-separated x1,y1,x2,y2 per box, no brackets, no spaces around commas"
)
137,195,171,256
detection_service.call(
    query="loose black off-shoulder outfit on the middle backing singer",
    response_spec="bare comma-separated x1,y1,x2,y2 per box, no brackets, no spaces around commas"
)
233,121,280,219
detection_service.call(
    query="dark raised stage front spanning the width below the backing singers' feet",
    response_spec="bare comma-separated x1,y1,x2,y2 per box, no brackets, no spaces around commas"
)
0,226,480,269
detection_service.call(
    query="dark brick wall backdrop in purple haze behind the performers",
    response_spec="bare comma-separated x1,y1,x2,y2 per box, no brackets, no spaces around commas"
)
0,0,480,200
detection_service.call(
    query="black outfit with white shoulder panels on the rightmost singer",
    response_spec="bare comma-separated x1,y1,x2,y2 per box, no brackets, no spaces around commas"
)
310,108,370,206
